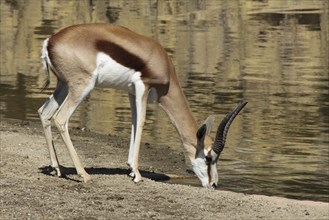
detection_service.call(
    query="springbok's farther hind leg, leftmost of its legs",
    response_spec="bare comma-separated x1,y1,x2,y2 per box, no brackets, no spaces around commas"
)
38,81,67,176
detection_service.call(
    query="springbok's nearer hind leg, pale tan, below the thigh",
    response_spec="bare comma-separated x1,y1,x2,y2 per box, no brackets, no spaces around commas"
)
53,84,92,182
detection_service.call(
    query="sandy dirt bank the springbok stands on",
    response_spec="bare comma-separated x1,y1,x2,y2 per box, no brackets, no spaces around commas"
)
0,119,329,220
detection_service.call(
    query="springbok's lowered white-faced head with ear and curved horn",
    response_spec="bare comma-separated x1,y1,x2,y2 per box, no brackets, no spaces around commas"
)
192,101,247,189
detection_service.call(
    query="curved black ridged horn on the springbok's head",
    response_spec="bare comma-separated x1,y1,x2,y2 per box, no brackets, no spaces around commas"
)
213,101,248,156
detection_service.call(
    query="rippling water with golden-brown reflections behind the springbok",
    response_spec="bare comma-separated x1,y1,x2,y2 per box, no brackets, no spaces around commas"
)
0,0,329,201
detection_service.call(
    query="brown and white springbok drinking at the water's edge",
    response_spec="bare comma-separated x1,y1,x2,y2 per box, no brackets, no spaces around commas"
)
38,24,247,188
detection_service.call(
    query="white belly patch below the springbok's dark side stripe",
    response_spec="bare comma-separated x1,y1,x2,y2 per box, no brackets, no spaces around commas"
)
94,52,141,94
